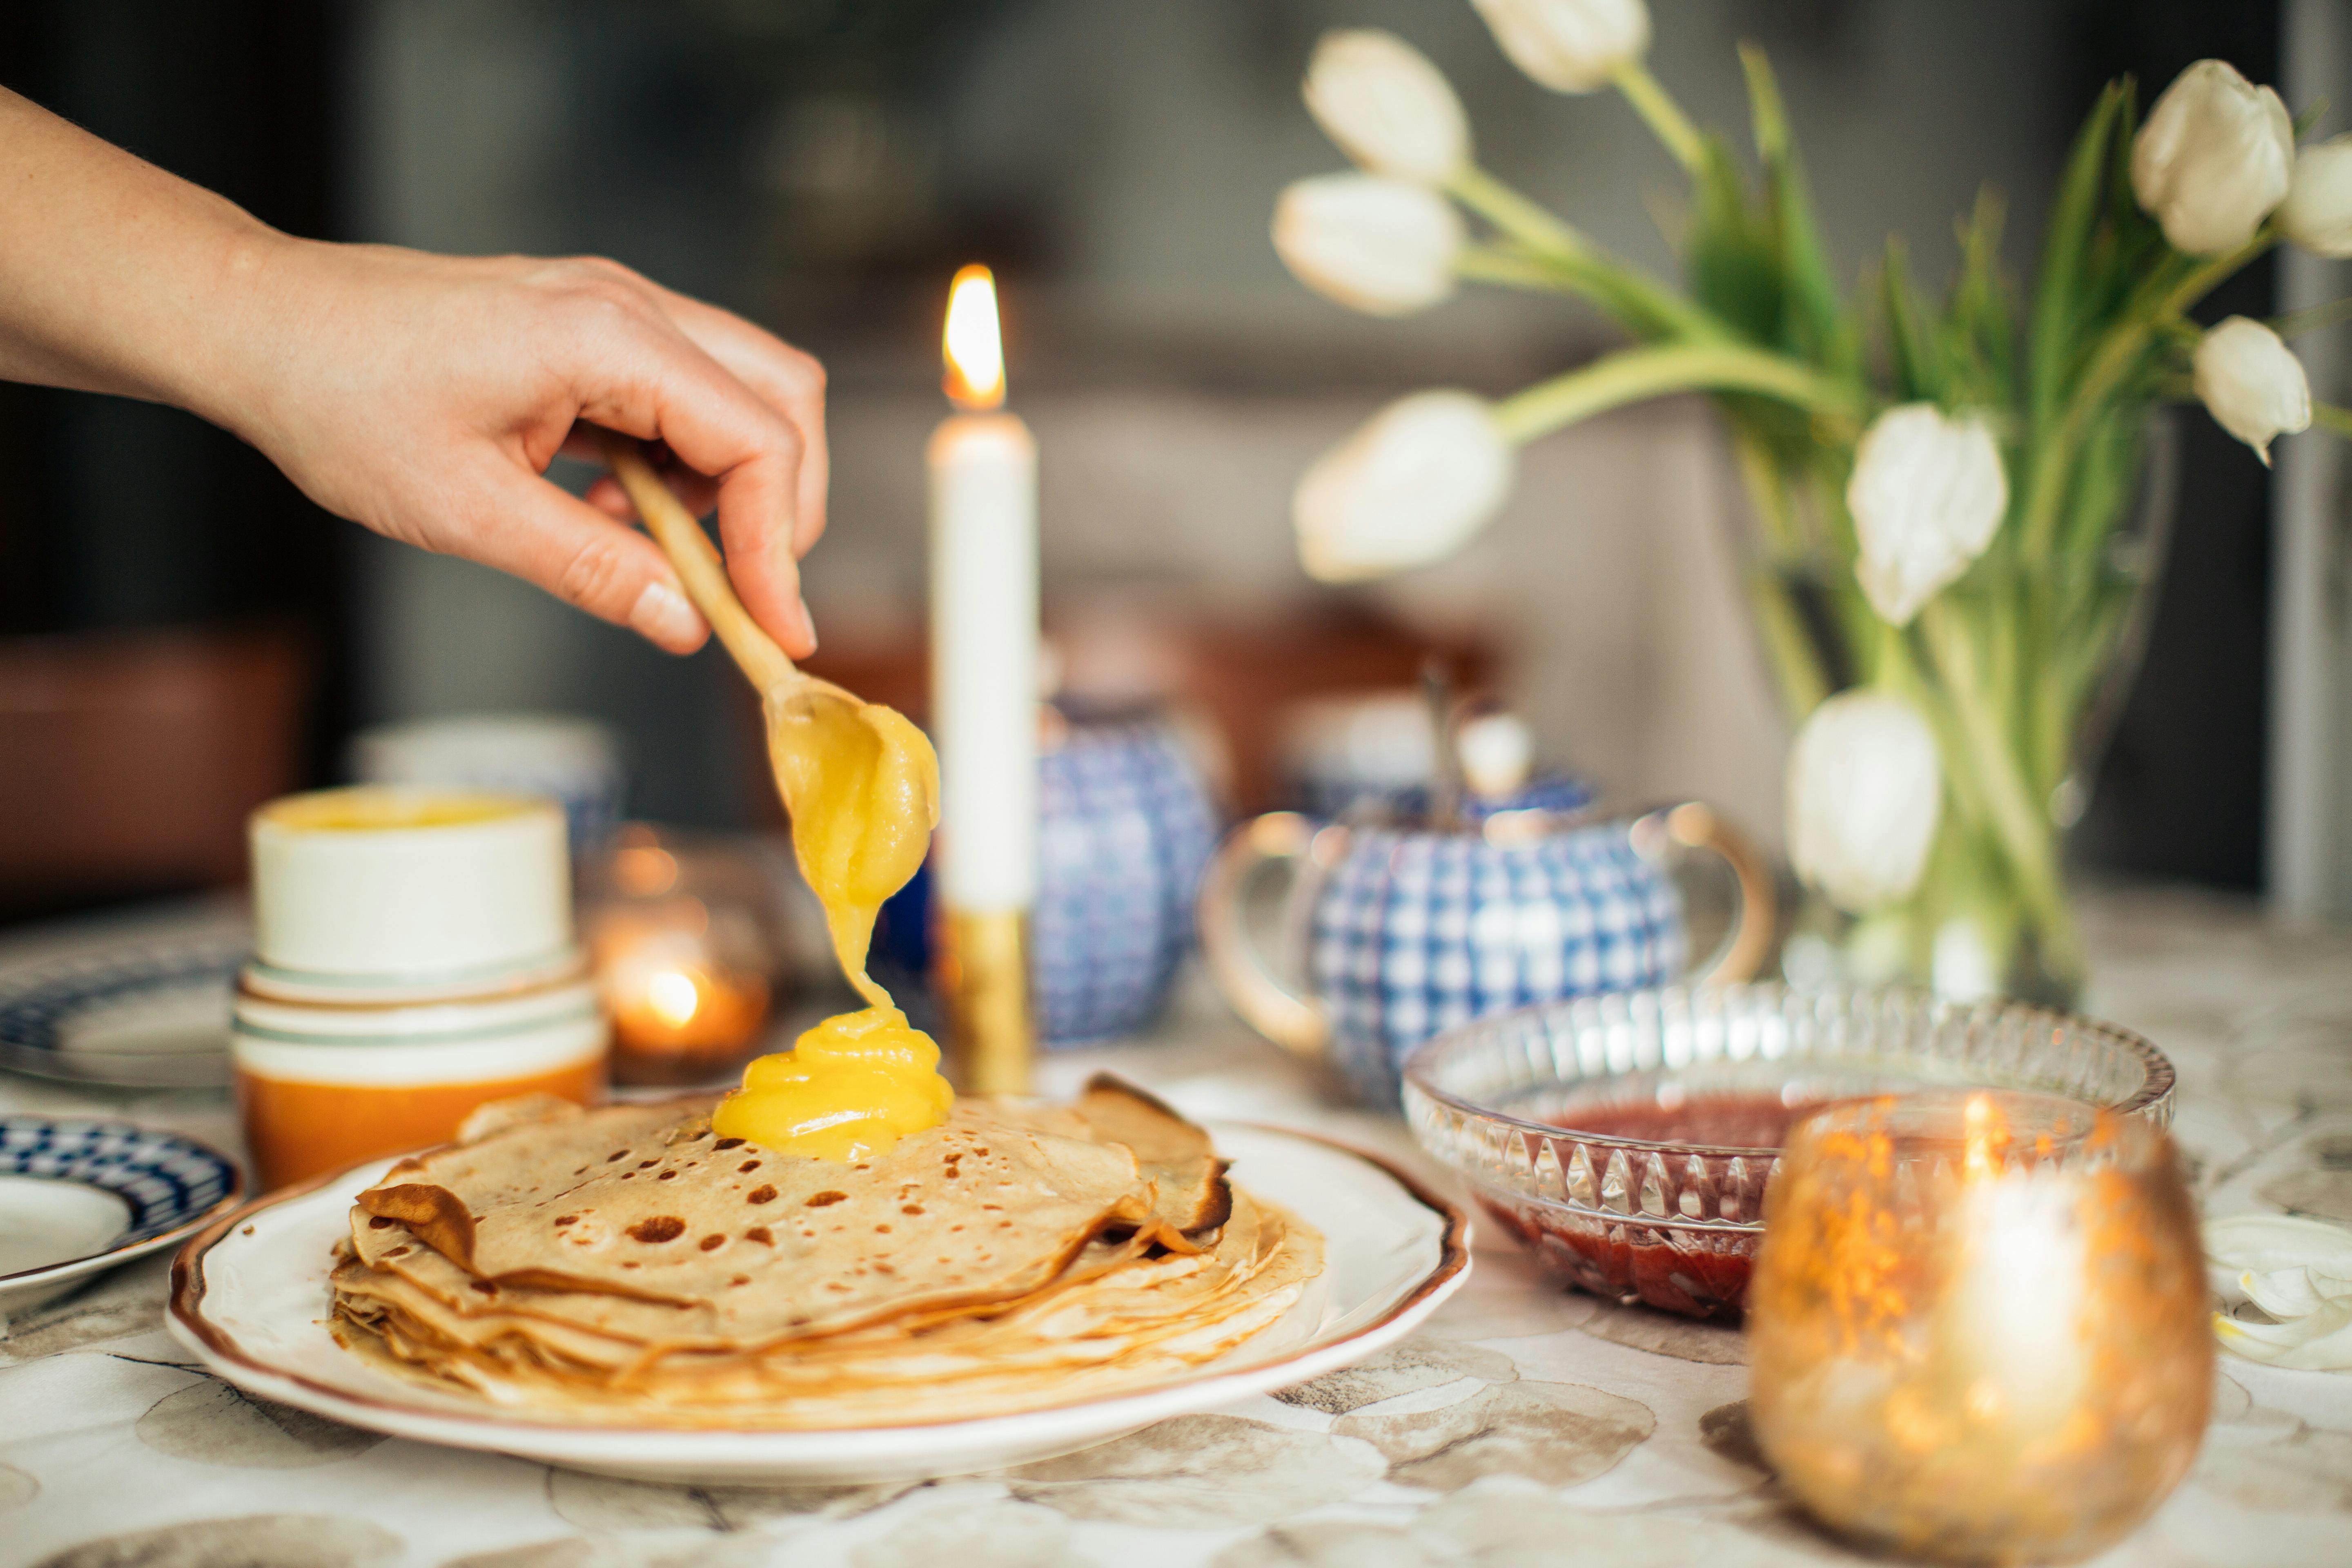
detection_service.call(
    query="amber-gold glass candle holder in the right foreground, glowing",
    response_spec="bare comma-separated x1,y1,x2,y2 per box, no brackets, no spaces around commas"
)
1748,1091,2213,1563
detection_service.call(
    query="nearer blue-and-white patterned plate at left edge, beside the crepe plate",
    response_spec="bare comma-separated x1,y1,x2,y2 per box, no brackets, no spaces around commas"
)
0,1117,245,1319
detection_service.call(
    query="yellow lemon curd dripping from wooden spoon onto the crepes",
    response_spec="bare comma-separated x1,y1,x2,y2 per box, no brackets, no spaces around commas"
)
710,684,955,1161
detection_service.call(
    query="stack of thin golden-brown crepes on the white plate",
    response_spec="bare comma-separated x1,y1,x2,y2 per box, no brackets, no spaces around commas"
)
334,1079,1322,1429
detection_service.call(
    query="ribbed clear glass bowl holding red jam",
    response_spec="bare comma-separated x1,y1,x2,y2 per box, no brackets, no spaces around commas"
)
1404,985,2173,1321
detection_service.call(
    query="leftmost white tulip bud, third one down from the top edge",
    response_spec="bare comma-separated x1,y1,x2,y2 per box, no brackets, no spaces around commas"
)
1275,174,1463,315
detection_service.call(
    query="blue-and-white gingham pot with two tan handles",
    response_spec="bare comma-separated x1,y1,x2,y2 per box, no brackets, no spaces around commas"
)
1200,780,1773,1107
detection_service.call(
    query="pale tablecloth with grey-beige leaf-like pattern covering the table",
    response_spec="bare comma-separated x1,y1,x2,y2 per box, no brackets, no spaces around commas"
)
0,891,2352,1568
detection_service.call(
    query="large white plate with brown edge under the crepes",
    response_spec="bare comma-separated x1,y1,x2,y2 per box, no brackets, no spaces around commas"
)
169,1124,1470,1483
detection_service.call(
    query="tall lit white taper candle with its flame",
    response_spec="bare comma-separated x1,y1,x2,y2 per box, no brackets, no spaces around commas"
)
927,268,1037,915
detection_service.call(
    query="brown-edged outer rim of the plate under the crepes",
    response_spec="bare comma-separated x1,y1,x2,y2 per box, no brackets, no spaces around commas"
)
165,1117,1472,1450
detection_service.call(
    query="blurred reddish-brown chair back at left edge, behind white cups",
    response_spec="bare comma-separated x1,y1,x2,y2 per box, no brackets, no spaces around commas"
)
0,630,308,917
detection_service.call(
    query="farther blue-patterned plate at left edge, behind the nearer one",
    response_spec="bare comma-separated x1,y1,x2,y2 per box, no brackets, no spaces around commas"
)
0,931,252,1089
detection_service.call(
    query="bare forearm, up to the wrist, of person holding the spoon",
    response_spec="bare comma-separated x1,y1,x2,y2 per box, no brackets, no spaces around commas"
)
0,89,296,423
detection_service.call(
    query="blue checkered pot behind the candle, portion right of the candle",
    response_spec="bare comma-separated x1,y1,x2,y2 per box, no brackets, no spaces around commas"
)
1030,705,1218,1046
